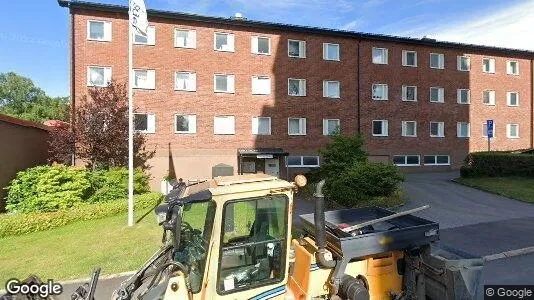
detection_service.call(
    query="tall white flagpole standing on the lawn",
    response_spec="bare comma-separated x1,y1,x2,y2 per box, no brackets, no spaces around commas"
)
128,0,134,227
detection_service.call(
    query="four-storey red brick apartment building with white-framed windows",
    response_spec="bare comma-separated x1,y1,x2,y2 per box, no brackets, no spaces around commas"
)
58,0,534,188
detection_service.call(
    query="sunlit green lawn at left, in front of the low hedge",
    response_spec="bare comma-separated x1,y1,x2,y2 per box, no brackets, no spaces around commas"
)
0,206,162,282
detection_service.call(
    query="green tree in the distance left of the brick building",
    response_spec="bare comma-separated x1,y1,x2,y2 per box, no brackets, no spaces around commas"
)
0,72,70,123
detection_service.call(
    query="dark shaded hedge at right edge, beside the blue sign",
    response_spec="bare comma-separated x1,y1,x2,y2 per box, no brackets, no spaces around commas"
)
460,151,534,177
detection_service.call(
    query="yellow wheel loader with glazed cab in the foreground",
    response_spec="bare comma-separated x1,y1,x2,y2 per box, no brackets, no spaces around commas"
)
72,174,482,300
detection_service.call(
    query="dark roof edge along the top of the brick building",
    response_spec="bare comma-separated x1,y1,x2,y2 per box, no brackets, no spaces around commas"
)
58,0,534,58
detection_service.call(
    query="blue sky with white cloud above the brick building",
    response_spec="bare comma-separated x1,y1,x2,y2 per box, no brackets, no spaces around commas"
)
0,0,534,96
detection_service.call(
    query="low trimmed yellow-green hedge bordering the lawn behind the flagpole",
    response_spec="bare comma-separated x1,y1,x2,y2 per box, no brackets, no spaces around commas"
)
0,192,162,238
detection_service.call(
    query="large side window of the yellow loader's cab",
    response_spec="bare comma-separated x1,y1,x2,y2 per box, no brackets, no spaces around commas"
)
217,194,289,294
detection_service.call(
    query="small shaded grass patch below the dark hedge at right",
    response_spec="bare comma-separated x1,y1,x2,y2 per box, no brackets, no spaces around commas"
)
456,177,534,203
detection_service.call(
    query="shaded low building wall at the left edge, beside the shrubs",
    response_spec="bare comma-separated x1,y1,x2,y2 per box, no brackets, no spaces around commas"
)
0,120,49,212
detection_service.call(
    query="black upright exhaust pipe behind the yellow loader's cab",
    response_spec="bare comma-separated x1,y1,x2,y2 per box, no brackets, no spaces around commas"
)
313,179,336,269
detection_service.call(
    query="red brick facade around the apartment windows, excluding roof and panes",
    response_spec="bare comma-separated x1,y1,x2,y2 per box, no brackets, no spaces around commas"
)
63,2,534,188
